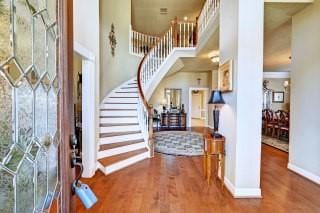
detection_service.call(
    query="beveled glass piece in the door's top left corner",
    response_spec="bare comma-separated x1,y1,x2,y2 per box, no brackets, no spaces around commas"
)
0,0,12,64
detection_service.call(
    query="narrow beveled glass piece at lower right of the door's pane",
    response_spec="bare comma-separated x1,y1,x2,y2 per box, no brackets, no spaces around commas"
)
48,144,58,192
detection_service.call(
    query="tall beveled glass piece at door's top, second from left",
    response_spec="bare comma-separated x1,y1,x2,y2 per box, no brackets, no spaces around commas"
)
13,0,32,70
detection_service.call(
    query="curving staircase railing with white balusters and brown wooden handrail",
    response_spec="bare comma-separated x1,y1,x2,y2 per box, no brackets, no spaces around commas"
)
135,0,220,156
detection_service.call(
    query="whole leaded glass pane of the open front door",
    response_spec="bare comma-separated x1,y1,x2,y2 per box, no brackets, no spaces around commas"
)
0,0,60,213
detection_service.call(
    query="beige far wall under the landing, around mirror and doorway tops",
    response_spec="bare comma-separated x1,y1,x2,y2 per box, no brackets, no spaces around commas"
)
149,72,211,125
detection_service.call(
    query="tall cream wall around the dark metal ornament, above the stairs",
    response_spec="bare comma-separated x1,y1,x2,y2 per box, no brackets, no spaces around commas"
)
100,0,142,100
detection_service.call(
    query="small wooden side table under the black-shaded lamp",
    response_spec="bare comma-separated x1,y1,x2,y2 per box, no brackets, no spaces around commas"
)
203,134,225,186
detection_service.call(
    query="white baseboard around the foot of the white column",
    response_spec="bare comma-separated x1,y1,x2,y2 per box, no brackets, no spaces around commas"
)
224,177,262,198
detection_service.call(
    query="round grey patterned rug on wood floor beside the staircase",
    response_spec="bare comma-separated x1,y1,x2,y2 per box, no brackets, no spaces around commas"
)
155,131,203,156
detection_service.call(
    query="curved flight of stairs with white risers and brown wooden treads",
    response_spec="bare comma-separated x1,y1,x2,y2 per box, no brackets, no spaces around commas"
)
97,79,150,175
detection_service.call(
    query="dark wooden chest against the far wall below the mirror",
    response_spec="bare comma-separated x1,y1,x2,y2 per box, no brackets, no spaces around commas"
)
161,113,187,130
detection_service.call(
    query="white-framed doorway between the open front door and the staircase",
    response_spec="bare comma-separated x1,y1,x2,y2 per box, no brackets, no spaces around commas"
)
73,42,98,177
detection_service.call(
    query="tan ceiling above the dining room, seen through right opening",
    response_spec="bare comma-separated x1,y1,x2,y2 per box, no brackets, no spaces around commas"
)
264,3,308,71
